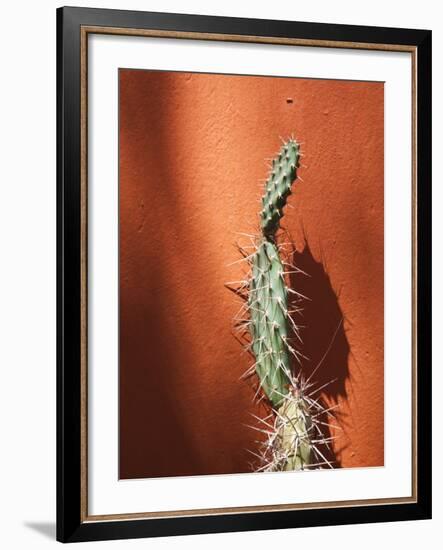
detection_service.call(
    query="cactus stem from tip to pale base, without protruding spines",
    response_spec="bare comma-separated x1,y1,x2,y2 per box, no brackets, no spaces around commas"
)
248,139,313,470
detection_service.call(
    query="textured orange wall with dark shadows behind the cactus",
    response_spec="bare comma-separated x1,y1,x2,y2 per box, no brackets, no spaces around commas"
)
119,70,384,478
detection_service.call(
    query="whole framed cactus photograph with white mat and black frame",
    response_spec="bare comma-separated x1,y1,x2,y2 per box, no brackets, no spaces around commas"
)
57,8,431,542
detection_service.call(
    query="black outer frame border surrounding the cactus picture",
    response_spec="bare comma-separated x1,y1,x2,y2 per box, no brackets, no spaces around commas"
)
57,7,431,542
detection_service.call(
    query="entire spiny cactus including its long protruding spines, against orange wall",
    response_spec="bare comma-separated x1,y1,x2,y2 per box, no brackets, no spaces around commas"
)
229,139,332,471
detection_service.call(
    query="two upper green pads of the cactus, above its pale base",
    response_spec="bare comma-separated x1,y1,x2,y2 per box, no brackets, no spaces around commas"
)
248,139,300,407
